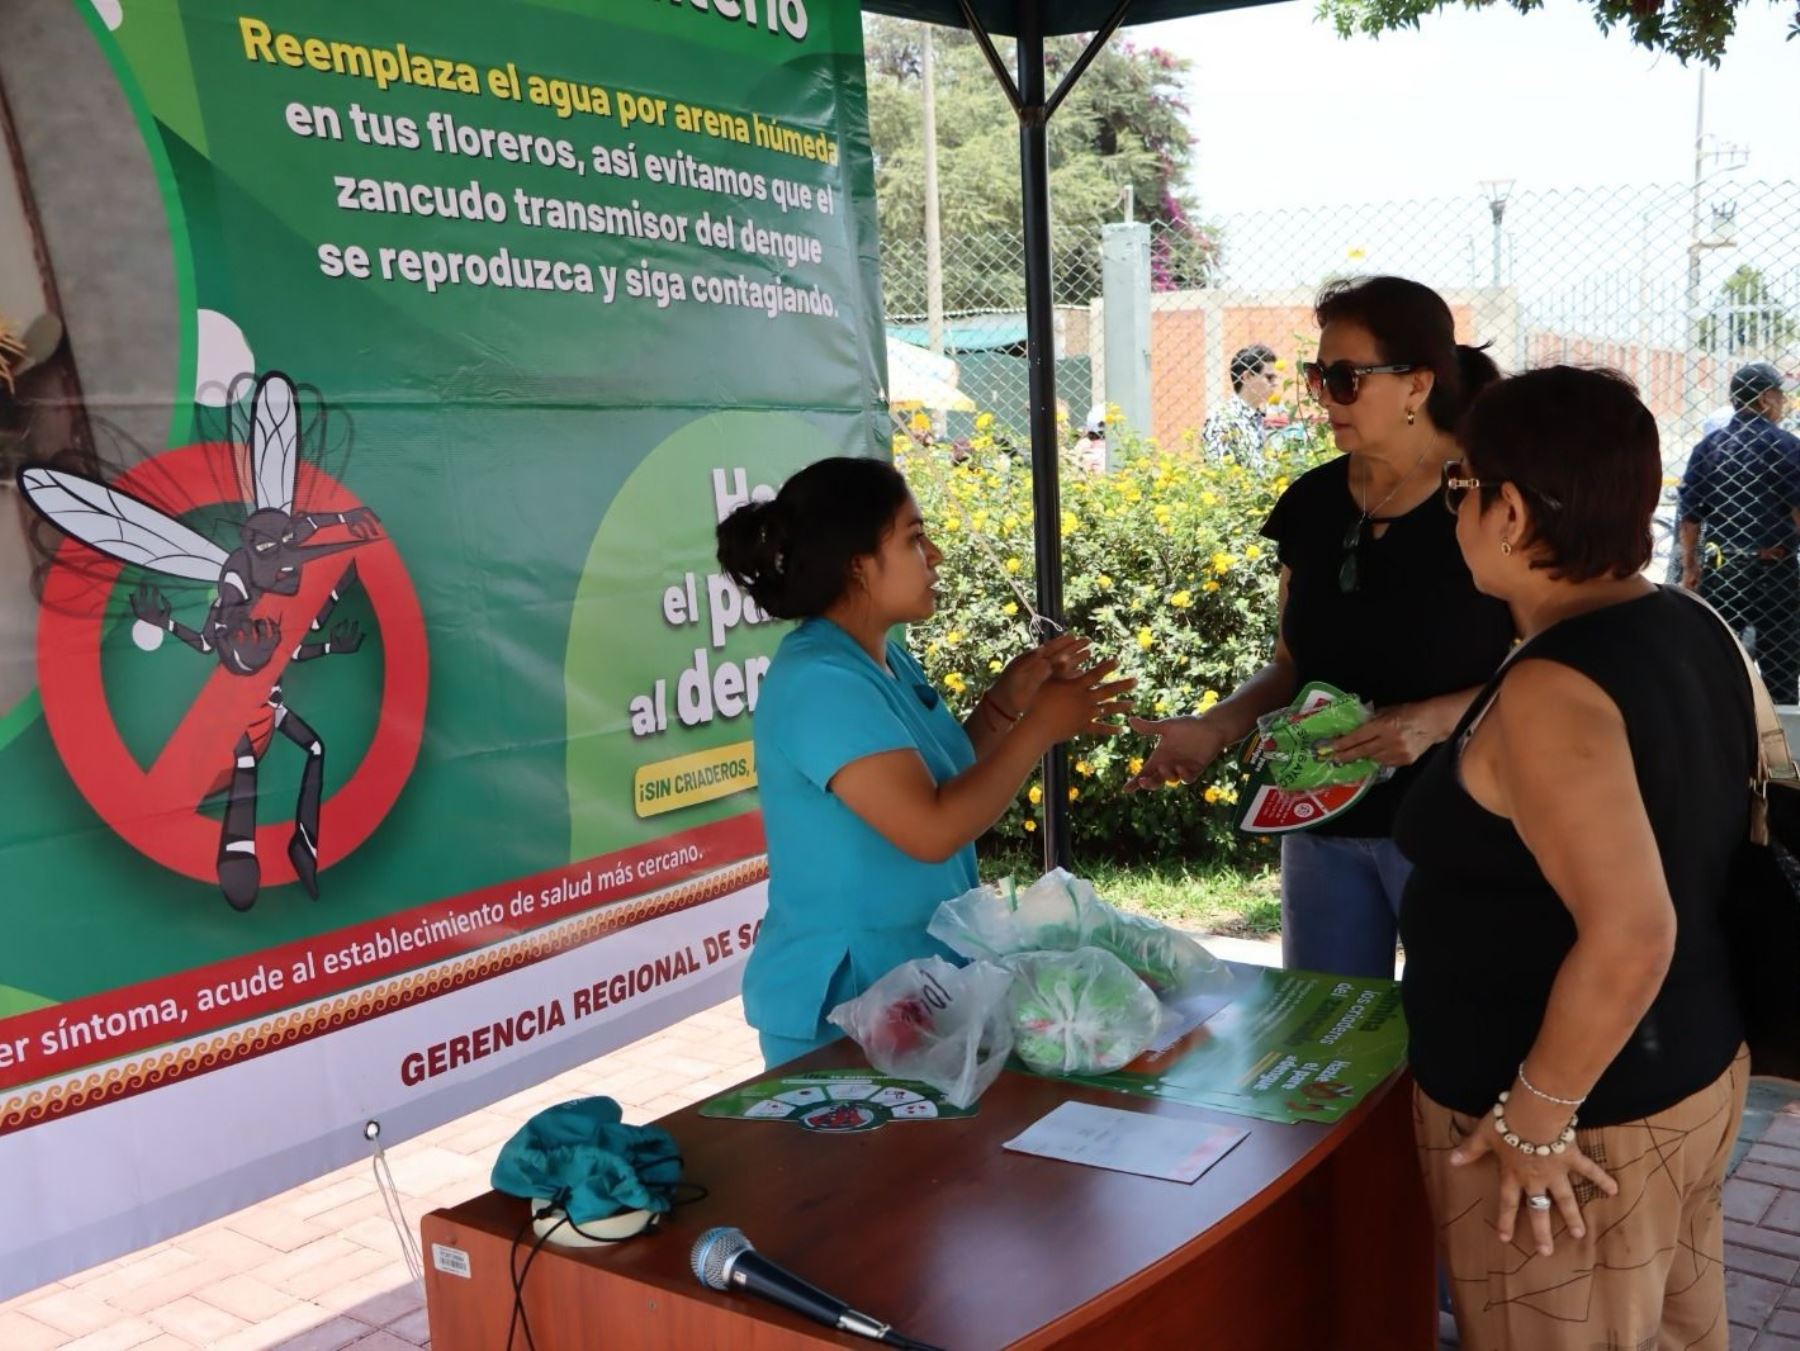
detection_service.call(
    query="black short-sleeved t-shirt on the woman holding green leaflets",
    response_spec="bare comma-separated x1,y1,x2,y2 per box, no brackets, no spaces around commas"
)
1262,455,1514,838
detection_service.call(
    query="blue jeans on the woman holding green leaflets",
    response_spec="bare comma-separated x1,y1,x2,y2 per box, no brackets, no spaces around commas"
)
1282,835,1413,980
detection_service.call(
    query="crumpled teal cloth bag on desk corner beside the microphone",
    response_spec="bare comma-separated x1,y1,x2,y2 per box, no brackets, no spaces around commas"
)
490,1097,680,1241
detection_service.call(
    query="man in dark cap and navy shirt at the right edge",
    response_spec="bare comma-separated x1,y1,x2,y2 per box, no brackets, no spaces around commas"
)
1681,362,1800,703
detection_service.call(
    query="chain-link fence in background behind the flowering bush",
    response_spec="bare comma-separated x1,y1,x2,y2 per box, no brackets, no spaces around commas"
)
882,178,1800,702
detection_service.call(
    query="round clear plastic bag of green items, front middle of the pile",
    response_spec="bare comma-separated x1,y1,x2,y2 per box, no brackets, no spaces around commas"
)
1001,948,1163,1074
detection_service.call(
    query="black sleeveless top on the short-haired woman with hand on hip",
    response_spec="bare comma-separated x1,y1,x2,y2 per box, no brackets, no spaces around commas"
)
1395,590,1755,1126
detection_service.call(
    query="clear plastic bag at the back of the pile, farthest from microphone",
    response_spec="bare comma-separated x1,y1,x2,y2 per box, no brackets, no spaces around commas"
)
929,867,1231,1002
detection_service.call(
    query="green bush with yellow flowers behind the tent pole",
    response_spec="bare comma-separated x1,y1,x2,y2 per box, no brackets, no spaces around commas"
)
895,404,1323,862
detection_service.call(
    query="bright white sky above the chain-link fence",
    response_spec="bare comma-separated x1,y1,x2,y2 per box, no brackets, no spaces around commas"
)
1127,0,1800,216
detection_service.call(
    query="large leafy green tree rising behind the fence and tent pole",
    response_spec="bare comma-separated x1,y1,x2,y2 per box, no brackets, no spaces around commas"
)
864,18,1217,313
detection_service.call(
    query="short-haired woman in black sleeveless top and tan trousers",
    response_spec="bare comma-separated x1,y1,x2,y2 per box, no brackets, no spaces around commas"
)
1395,367,1755,1351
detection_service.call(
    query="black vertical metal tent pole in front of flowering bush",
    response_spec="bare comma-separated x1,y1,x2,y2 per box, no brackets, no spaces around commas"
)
1017,0,1073,871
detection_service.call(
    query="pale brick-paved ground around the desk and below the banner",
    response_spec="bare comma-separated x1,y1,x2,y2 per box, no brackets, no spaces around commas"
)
10,939,1800,1351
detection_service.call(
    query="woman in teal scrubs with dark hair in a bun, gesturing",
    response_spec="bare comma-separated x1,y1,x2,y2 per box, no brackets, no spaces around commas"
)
718,459,1130,1065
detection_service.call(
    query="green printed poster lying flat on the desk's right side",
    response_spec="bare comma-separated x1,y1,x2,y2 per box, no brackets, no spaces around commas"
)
1082,966,1406,1123
